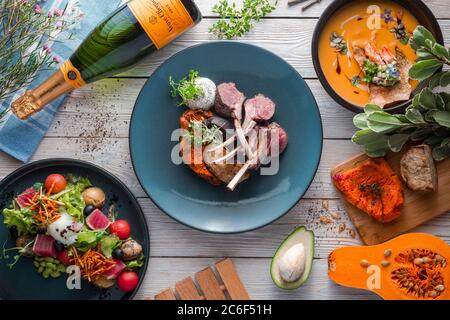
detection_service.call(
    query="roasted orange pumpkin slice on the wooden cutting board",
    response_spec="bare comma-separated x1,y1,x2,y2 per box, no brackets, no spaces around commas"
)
333,158,405,223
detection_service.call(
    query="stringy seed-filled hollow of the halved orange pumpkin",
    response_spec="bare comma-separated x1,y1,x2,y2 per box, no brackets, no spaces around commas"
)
391,249,449,299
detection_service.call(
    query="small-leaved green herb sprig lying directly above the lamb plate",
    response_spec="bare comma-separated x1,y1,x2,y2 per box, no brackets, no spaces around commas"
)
209,0,278,39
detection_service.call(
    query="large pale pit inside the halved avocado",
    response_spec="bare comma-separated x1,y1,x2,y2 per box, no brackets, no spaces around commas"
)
278,243,306,283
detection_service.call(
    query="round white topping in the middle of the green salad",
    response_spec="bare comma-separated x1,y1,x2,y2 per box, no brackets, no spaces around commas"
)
47,213,83,246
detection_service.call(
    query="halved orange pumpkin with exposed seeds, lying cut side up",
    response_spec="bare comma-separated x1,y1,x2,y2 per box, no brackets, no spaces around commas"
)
328,233,450,300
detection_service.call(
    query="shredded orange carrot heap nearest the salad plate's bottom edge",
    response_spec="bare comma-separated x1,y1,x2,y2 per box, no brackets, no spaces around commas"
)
72,248,114,282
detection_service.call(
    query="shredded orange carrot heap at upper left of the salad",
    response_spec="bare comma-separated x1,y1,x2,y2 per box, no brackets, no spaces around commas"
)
28,193,64,228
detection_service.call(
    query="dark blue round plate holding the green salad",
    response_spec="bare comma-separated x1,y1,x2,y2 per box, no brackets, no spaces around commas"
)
0,159,150,300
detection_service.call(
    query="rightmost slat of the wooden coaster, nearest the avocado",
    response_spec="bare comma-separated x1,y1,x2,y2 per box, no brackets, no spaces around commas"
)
216,259,250,300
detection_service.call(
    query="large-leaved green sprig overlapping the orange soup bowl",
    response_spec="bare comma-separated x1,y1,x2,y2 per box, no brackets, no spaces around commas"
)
352,26,450,161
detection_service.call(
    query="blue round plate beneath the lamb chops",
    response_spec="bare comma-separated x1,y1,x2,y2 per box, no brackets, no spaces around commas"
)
130,41,322,233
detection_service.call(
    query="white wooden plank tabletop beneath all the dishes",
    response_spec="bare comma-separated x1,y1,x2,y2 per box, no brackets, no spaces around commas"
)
0,0,450,299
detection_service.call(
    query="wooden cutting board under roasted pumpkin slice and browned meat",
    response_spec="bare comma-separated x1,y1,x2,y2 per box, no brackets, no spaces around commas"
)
331,153,450,245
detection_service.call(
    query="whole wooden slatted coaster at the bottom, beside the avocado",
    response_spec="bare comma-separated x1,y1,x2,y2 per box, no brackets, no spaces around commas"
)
155,259,250,300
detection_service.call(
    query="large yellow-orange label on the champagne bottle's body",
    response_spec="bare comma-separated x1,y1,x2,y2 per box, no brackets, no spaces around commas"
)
128,0,194,49
